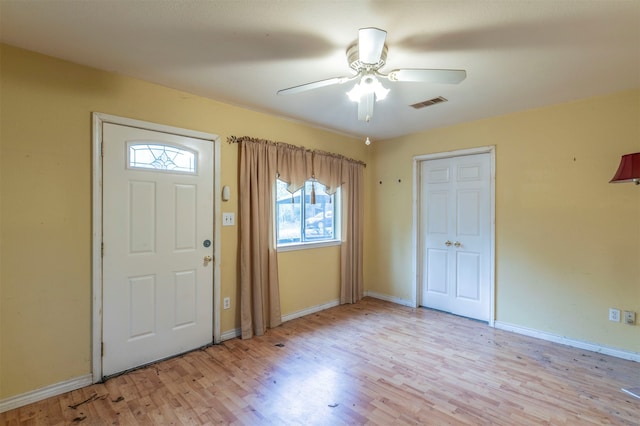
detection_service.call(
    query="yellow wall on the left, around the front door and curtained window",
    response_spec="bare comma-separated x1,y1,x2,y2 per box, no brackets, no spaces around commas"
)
0,45,369,400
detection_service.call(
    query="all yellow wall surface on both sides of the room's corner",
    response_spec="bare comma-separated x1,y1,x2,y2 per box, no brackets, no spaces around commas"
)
0,42,640,400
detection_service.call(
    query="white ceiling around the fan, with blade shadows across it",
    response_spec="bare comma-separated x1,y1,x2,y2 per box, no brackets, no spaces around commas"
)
0,0,640,140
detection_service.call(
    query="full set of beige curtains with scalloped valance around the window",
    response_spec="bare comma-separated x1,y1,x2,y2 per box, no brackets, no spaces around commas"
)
236,137,364,339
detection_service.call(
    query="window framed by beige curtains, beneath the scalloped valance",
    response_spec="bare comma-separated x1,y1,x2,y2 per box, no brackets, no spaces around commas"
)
276,179,340,247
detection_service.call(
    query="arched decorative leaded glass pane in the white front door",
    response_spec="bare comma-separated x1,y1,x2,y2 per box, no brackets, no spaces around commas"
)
129,142,196,173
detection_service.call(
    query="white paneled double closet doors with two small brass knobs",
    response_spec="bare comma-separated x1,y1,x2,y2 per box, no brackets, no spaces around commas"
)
419,153,493,321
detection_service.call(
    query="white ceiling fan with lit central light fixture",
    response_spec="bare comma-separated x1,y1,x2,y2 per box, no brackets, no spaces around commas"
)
278,28,467,122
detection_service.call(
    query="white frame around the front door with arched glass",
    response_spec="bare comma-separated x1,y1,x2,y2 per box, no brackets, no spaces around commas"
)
91,112,222,383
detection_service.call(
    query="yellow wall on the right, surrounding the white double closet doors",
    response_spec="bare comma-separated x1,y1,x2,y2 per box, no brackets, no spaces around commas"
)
367,90,640,353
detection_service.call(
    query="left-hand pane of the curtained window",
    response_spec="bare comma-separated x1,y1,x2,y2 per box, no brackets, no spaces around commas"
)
276,179,302,244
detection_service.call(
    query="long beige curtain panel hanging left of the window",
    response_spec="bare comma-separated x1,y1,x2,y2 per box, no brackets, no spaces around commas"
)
239,141,282,339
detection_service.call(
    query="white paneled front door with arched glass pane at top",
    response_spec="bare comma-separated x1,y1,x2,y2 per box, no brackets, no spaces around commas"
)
102,123,214,376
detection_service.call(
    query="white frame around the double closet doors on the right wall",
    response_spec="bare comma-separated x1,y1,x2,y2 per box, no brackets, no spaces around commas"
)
412,146,496,327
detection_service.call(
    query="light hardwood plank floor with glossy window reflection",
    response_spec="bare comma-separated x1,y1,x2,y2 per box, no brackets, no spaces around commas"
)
0,298,640,426
